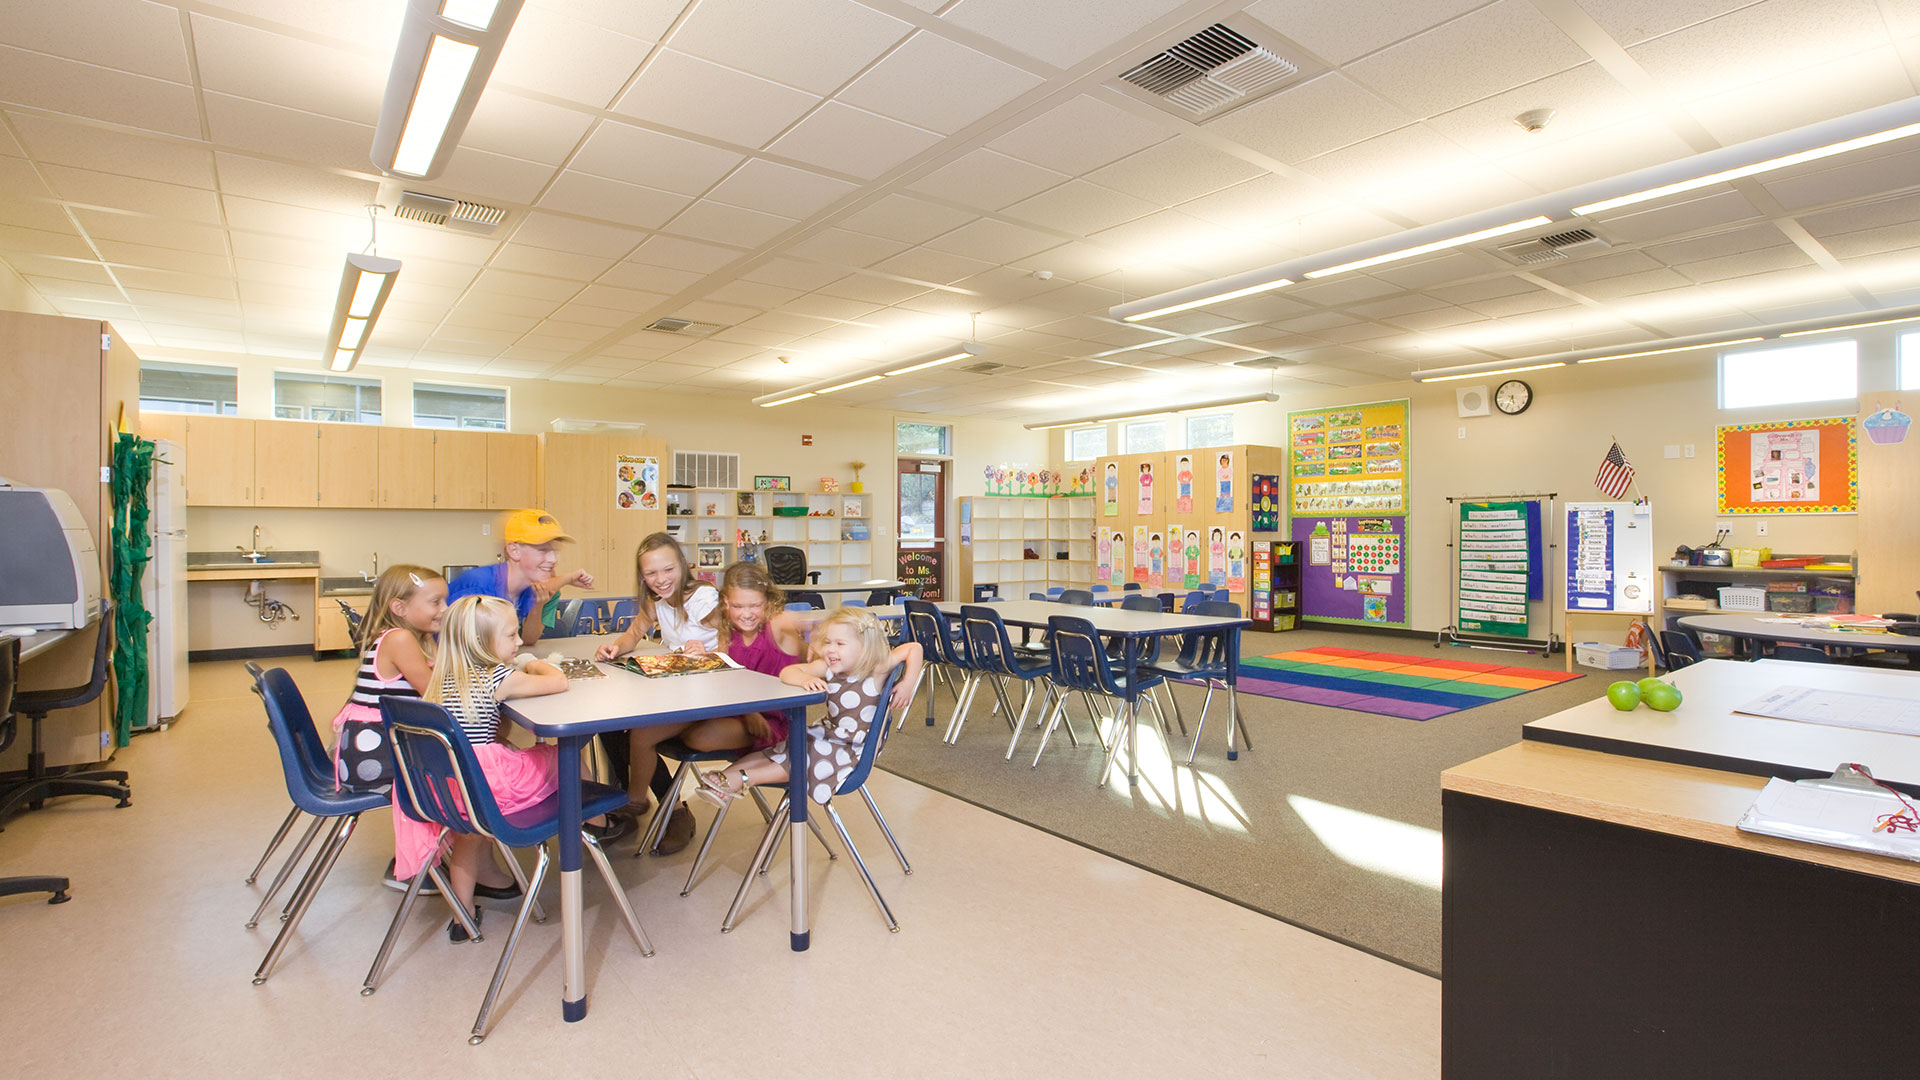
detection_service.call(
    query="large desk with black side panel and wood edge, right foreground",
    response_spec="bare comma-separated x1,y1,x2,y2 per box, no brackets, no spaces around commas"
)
1440,659,1920,1080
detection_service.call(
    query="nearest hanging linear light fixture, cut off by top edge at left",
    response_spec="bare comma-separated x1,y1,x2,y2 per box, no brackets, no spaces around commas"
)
372,0,520,179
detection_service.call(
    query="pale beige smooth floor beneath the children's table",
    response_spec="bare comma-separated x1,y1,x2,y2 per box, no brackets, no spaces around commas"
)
0,661,1440,1080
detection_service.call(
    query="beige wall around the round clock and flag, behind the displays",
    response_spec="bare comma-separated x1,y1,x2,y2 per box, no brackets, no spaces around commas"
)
1052,323,1920,638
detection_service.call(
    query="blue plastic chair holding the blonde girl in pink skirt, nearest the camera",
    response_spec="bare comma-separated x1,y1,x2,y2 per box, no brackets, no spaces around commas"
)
361,698,653,1045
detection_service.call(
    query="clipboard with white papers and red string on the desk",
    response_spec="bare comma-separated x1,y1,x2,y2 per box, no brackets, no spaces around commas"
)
1734,763,1920,863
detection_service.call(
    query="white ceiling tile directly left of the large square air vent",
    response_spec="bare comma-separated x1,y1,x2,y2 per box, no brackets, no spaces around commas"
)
835,31,1041,135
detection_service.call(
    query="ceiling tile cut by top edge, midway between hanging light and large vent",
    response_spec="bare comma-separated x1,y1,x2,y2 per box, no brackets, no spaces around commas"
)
674,0,912,94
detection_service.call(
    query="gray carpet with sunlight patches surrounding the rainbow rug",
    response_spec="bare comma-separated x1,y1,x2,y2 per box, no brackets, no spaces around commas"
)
879,618,1611,974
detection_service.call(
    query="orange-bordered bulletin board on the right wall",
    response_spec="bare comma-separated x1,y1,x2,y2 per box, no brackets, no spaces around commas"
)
1715,417,1860,515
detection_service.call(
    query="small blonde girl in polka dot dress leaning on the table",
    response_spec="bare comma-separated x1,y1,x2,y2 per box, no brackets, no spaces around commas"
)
699,607,922,805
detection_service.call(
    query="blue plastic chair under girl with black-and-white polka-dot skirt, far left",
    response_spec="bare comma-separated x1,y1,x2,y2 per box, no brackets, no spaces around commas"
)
248,667,388,986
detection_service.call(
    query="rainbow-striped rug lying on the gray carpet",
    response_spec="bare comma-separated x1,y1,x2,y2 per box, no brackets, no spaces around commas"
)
1240,646,1580,721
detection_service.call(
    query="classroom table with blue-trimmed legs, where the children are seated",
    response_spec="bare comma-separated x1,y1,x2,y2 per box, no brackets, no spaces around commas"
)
499,636,826,1022
